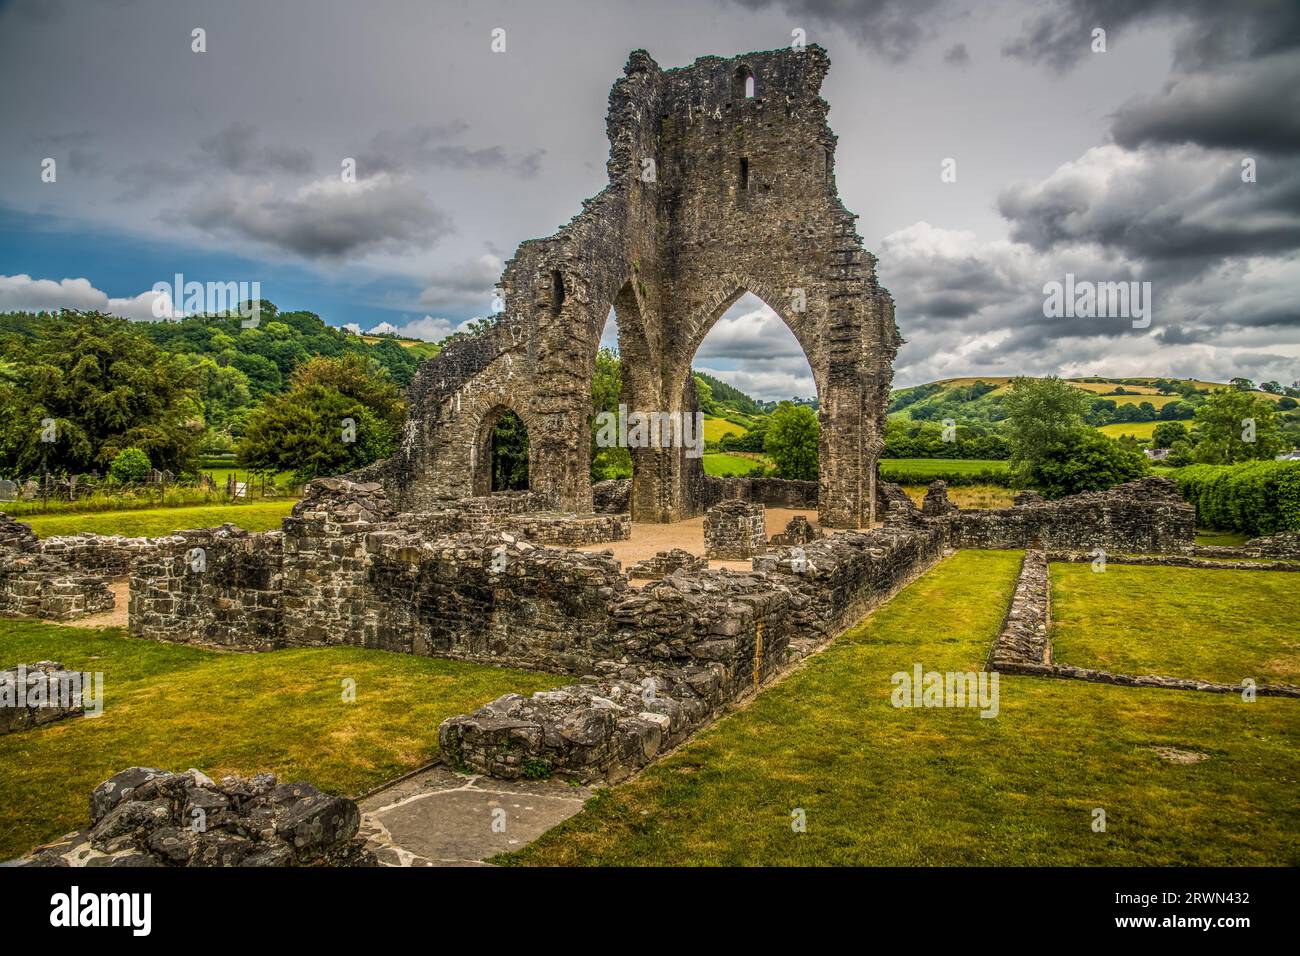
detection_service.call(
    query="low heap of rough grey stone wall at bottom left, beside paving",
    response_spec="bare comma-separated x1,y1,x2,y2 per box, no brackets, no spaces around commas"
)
18,767,374,866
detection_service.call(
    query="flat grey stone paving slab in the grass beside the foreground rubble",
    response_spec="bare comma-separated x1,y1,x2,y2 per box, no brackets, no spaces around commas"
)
360,763,593,866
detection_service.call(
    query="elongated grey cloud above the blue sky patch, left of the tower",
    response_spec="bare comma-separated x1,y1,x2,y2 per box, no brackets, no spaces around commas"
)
182,174,454,260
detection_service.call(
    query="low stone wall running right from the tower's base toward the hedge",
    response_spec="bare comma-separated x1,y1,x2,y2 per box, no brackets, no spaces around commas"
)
945,477,1196,554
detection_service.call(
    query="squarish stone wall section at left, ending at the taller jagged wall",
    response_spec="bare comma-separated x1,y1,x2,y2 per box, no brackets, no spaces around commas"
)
127,524,283,650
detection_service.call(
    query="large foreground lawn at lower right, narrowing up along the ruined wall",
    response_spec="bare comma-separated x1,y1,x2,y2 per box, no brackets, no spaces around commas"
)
506,551,1300,866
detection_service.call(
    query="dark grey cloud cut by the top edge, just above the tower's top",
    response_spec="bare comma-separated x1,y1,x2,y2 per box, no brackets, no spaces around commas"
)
731,0,941,62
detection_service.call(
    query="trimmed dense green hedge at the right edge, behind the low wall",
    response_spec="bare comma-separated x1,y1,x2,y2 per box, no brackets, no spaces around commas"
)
1173,462,1300,536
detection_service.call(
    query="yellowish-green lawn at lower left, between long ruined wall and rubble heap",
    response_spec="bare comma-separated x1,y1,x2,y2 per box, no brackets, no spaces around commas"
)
0,620,563,860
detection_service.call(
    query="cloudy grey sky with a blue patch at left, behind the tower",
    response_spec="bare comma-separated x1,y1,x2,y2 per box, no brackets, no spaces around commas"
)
0,0,1300,399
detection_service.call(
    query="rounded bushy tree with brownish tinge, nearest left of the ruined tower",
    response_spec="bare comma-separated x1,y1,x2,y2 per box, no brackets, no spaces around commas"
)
238,354,406,481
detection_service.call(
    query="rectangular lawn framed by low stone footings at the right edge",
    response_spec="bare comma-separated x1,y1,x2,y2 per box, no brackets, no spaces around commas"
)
1052,563,1300,686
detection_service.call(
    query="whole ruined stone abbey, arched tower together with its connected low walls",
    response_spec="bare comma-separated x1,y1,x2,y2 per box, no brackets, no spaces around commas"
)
0,47,1237,806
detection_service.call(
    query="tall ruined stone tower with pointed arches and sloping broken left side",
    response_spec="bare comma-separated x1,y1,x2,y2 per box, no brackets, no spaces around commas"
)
374,46,901,527
